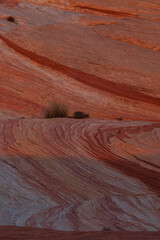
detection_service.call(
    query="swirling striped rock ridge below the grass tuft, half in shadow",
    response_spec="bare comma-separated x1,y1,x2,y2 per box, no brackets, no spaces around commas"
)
0,119,160,231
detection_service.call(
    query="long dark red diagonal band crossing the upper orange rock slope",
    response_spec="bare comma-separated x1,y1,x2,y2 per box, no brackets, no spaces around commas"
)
0,35,160,107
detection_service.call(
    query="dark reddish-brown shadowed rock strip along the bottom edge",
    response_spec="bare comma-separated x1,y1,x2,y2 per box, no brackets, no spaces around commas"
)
0,227,160,240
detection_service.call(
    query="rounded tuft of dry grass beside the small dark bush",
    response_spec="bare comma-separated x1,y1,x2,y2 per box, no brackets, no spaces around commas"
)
45,102,68,118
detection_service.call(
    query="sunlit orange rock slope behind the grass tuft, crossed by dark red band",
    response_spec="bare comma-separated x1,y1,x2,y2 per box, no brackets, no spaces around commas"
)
0,0,160,121
